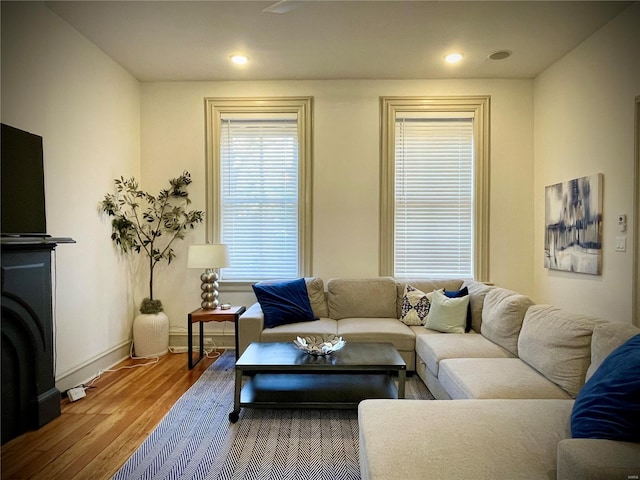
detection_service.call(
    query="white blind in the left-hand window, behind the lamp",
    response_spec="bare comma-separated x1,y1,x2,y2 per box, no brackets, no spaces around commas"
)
220,114,299,281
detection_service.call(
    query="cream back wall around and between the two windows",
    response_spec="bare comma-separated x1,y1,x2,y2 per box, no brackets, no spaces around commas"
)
141,80,533,342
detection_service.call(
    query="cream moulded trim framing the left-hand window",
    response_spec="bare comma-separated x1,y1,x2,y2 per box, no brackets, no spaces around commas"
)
205,97,313,285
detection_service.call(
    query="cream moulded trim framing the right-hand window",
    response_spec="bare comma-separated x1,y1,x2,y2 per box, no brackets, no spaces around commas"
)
379,95,491,282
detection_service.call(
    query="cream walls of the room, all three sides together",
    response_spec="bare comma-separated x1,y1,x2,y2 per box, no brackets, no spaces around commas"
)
20,2,640,368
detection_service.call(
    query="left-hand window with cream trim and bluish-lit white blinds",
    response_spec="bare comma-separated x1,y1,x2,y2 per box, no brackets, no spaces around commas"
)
206,98,312,283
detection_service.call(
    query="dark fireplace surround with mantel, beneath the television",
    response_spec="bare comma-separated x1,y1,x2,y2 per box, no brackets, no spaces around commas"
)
1,237,73,444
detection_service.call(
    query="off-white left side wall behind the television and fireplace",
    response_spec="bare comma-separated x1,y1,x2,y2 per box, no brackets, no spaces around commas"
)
2,2,140,390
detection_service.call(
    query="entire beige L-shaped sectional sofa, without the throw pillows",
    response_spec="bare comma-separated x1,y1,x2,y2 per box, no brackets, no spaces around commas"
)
238,277,640,480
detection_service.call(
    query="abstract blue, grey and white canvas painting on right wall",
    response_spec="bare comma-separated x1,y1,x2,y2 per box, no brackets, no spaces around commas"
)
544,174,603,275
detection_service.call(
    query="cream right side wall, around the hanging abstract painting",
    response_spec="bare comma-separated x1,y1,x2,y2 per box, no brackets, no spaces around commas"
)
533,2,640,322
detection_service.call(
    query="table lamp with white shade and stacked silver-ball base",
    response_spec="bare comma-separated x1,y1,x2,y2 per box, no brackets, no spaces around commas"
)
187,243,229,310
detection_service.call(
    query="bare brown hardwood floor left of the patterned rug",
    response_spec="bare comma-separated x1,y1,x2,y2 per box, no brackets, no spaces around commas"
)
1,353,222,480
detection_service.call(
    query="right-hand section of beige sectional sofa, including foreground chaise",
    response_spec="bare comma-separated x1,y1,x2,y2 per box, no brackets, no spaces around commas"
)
358,285,640,480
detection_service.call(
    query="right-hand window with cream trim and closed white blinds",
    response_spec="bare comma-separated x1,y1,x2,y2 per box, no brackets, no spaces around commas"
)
380,97,489,281
